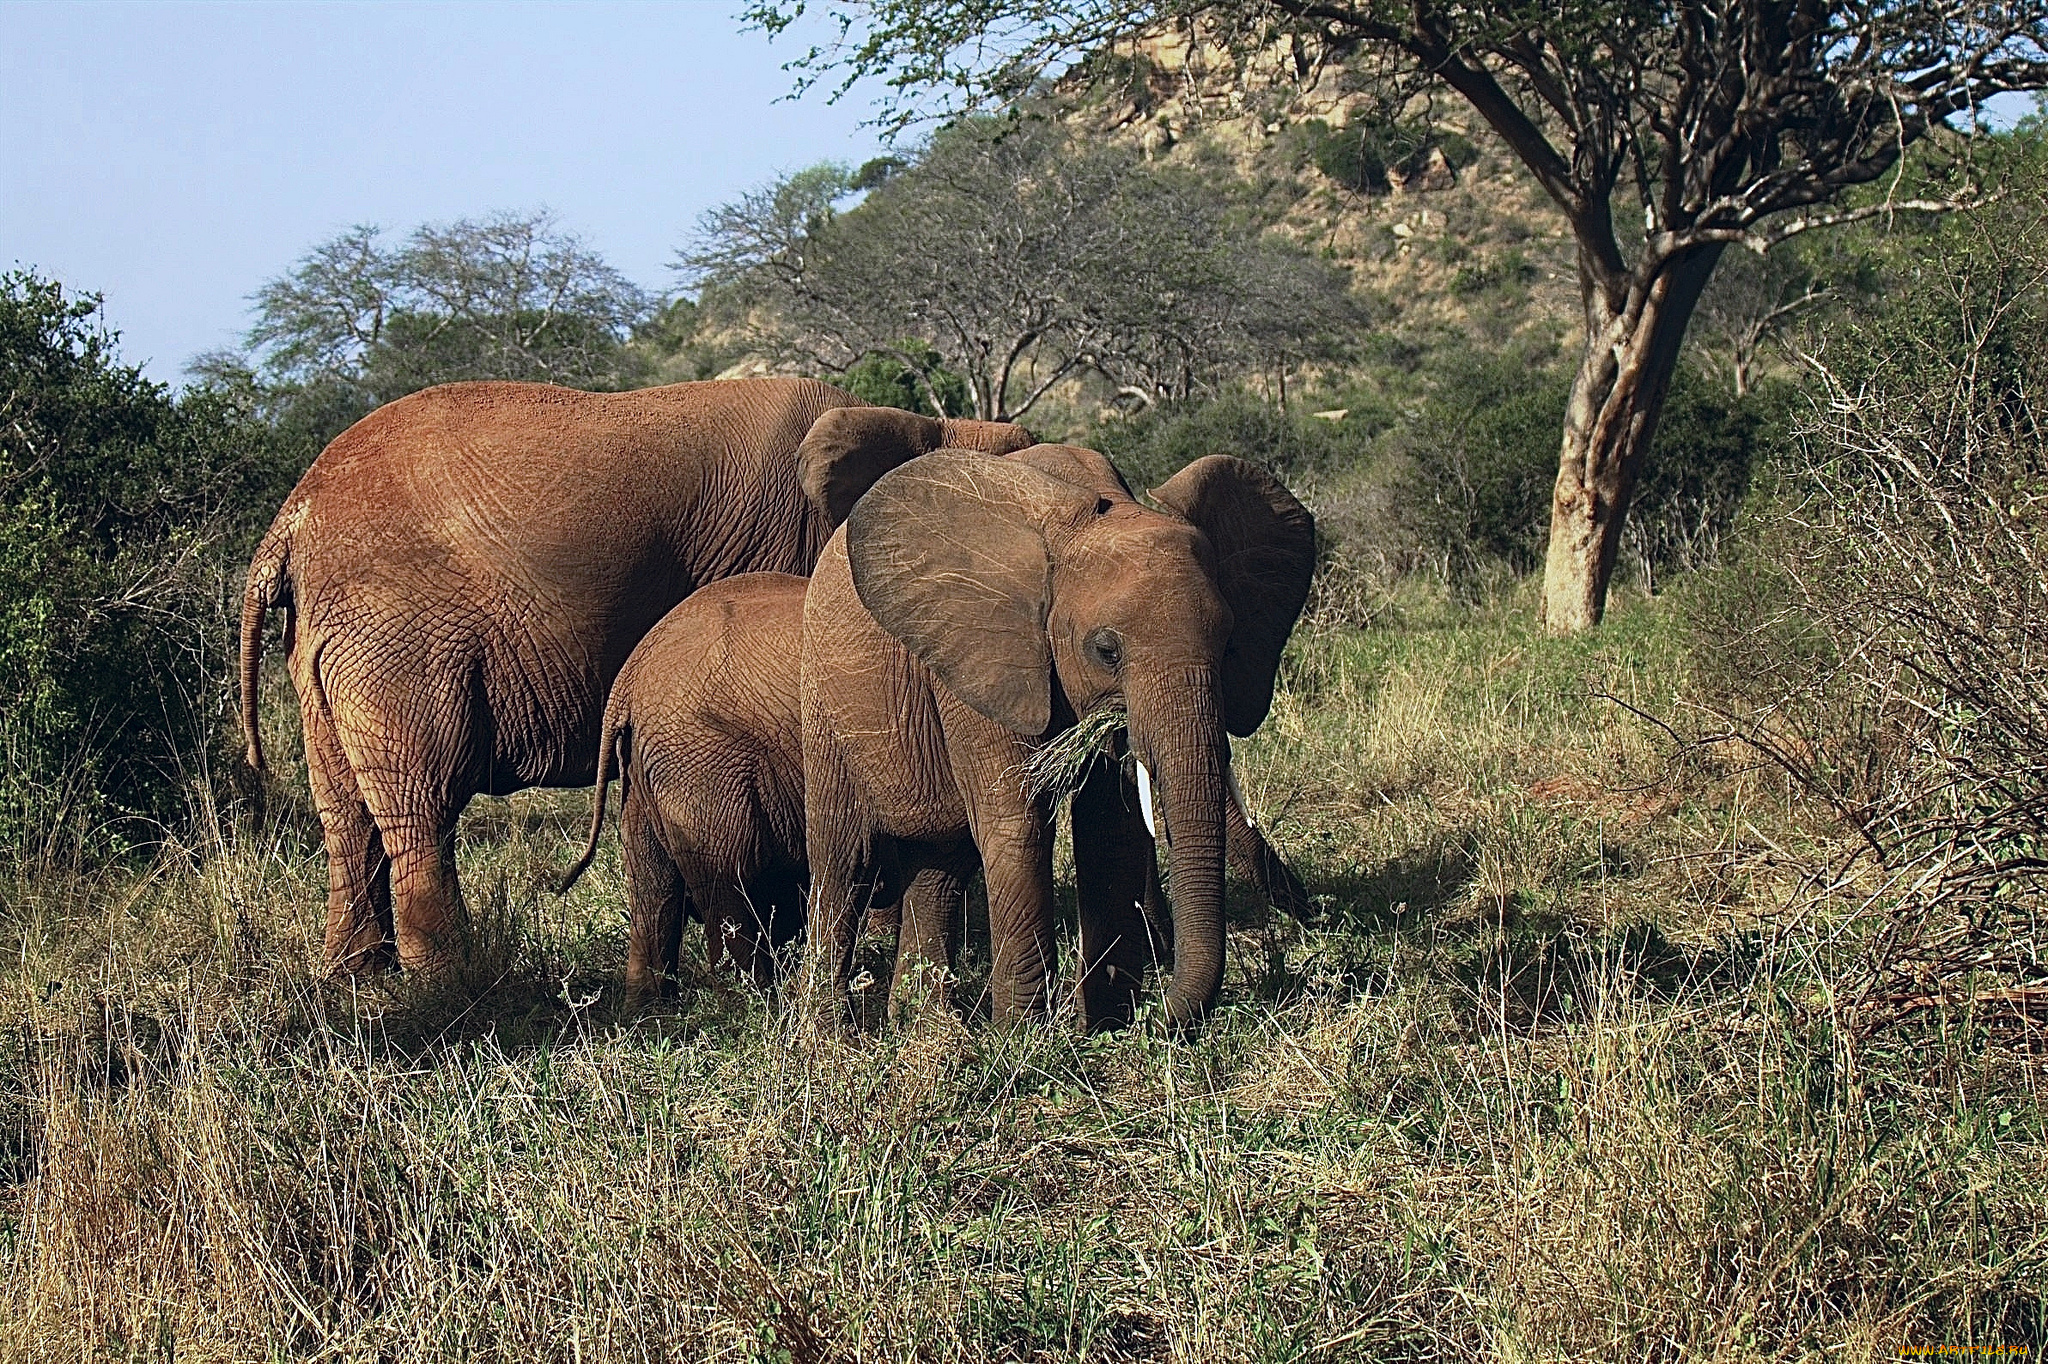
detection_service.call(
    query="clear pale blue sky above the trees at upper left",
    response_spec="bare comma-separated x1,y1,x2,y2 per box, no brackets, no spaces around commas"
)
0,0,879,381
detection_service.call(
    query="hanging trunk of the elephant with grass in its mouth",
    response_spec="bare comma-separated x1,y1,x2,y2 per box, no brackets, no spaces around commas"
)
1126,670,1231,1028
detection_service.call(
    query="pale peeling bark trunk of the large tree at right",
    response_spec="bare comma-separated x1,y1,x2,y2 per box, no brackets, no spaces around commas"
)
1542,246,1720,635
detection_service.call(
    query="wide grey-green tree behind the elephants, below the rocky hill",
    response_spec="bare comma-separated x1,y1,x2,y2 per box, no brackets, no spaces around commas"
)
678,119,1350,420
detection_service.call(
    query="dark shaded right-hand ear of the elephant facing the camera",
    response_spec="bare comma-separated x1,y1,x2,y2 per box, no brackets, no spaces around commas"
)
1151,455,1315,737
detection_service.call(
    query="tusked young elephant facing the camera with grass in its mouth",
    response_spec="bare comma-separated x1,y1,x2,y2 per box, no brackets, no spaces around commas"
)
801,451,1315,1024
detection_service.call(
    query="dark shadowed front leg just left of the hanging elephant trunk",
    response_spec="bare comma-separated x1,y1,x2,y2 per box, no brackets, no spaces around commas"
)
1073,762,1157,1030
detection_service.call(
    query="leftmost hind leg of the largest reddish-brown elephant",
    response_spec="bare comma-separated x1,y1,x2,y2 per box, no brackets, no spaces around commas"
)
299,675,395,975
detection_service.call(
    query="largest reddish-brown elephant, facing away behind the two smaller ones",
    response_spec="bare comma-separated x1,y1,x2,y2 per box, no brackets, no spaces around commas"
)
242,379,1030,971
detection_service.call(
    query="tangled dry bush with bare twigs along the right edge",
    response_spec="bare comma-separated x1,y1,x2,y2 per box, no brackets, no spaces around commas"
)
1702,186,2048,1051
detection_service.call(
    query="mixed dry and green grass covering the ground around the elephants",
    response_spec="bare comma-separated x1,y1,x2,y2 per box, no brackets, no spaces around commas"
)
0,590,2048,1362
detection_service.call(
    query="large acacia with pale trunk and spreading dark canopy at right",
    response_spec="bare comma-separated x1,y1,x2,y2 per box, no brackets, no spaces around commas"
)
748,0,2048,633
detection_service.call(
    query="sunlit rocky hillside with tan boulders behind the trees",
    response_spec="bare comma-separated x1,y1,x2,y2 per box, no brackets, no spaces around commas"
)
1059,35,1579,382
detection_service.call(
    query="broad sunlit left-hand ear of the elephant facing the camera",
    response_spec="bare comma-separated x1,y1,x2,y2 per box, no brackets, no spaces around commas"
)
846,451,1096,735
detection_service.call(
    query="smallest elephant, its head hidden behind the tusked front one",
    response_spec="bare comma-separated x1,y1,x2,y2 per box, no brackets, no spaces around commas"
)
561,573,963,999
